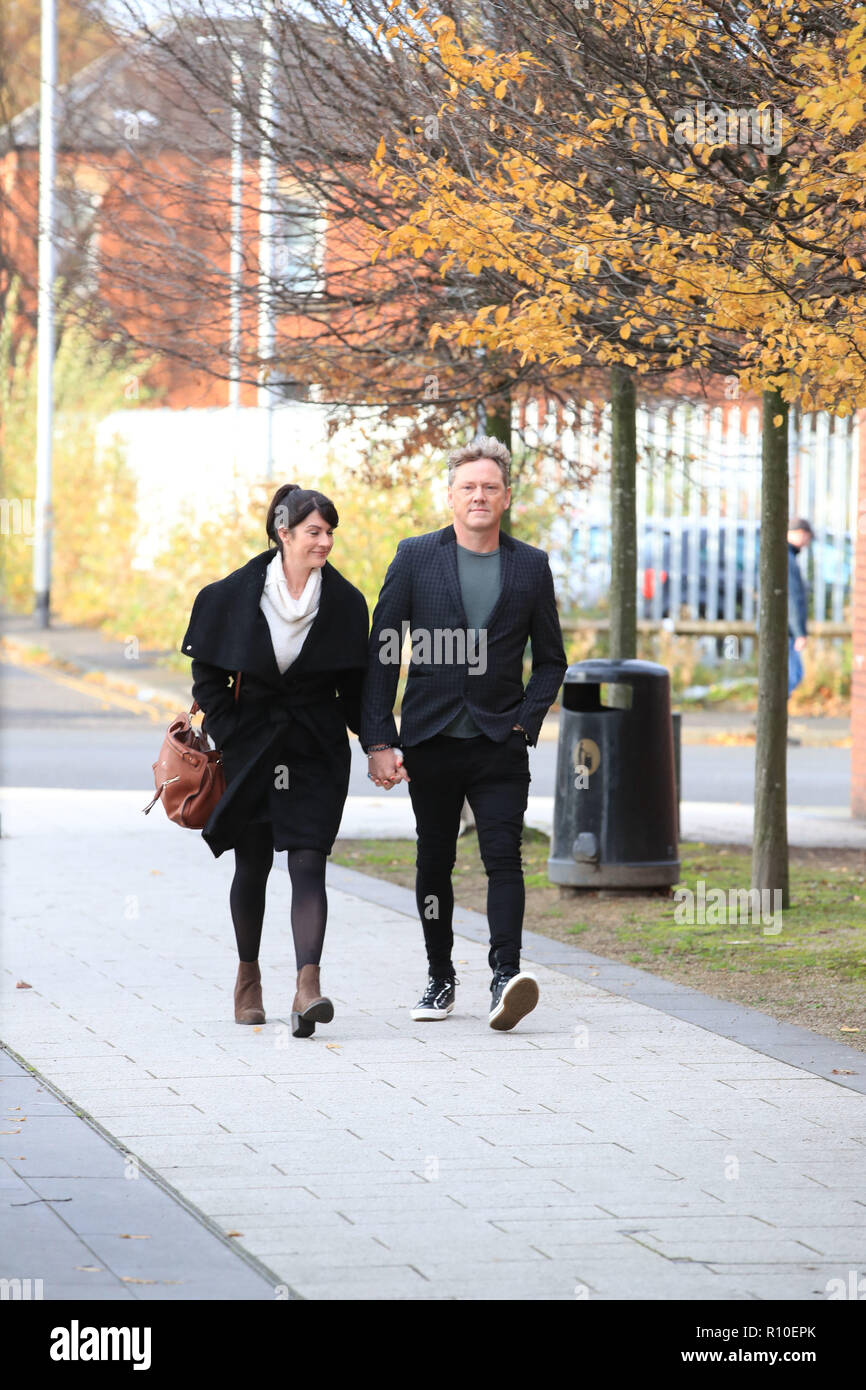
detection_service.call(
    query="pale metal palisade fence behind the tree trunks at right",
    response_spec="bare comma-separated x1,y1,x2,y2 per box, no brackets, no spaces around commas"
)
536,400,858,624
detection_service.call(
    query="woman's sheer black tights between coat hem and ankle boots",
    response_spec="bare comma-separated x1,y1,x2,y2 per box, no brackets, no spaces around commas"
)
228,821,328,970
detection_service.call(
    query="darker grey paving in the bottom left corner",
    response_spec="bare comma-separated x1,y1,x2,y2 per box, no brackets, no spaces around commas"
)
0,1049,278,1302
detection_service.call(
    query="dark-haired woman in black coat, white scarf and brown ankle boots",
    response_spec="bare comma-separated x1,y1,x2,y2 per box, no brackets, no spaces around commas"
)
183,482,368,1037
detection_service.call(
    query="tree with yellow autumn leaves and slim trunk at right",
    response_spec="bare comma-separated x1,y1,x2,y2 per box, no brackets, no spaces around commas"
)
374,0,866,904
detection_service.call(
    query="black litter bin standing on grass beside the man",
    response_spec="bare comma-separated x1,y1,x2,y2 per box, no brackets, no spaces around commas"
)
548,660,680,888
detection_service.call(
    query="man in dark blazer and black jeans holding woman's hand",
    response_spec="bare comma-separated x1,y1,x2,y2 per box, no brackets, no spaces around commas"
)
360,438,567,1029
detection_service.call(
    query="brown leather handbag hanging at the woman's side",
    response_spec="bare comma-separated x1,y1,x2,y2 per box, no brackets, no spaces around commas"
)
142,671,240,830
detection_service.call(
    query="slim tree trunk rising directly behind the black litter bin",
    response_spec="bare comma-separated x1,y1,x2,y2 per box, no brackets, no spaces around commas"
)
610,367,638,660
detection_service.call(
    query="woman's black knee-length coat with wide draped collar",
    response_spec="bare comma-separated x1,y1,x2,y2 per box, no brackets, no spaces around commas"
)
182,550,370,856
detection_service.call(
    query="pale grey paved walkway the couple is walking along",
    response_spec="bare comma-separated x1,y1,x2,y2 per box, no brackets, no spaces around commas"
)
0,791,866,1300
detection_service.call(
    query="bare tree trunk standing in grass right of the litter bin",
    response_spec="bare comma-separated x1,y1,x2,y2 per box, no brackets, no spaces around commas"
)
752,391,790,908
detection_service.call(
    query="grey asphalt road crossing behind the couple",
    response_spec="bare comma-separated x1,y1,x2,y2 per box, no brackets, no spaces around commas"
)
0,663,851,808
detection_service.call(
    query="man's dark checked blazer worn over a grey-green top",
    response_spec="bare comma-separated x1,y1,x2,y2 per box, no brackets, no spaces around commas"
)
359,525,567,751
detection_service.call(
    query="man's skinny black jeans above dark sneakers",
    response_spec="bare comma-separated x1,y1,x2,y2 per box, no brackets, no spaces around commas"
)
403,730,530,976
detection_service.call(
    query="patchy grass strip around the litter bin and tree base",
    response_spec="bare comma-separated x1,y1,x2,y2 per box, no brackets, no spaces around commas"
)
332,831,866,1051
